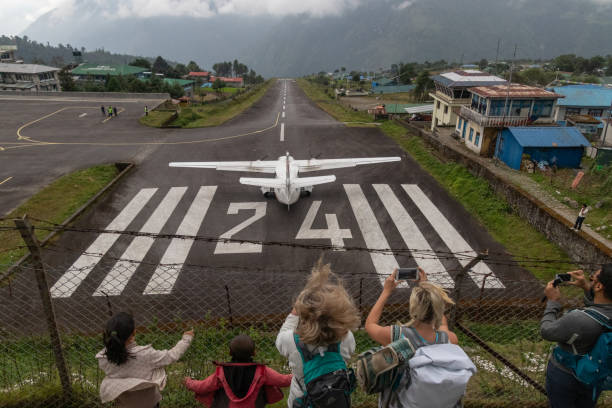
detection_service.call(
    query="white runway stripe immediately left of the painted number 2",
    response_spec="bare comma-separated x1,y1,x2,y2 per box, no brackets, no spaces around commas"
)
143,186,217,295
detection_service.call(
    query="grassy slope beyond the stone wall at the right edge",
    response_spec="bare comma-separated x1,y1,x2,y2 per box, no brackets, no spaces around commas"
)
530,158,612,239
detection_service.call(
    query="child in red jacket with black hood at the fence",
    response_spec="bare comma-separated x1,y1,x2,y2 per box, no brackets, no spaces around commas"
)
185,334,291,408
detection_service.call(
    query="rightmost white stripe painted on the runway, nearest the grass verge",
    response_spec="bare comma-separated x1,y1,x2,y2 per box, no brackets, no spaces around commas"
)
402,184,504,289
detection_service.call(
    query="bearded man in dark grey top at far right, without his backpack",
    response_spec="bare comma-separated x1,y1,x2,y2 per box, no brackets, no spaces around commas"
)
540,264,612,408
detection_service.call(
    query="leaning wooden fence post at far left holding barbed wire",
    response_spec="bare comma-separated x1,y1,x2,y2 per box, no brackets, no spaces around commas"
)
15,216,72,399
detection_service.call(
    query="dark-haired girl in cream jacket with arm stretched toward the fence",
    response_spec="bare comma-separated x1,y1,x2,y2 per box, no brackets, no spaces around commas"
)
96,312,193,408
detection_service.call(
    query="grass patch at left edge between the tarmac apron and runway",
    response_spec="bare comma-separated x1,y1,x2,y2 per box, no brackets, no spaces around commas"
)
0,164,119,272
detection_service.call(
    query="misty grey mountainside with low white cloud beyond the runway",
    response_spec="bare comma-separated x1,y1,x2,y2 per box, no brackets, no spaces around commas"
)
23,0,612,76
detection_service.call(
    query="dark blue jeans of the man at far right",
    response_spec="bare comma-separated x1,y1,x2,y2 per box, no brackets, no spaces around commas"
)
546,361,599,408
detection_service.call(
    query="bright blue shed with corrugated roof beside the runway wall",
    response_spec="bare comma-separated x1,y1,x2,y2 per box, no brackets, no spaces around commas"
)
495,126,590,170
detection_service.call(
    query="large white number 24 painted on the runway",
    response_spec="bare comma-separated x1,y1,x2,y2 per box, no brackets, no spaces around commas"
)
214,201,353,254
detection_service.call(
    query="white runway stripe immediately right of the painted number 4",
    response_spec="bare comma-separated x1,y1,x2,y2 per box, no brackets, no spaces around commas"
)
344,184,399,284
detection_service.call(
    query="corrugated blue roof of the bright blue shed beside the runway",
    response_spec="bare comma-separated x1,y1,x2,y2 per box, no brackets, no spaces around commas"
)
508,126,591,147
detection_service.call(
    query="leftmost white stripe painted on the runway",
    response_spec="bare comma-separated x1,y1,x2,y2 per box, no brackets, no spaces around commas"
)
50,188,157,298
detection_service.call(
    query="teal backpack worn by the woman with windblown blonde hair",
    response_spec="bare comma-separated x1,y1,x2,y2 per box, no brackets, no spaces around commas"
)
293,333,356,408
